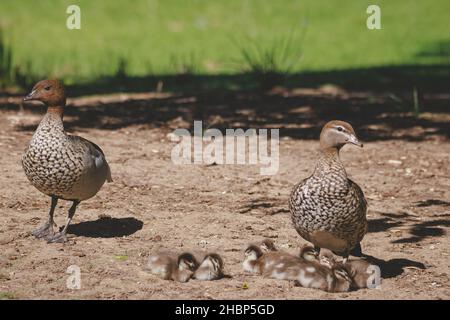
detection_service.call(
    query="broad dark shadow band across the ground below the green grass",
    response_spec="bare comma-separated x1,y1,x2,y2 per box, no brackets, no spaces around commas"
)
0,65,450,141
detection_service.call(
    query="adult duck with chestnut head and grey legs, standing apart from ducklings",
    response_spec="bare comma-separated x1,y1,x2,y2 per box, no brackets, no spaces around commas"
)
22,80,112,242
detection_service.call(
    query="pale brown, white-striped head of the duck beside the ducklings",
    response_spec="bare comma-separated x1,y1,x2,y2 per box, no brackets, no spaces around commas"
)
320,120,363,149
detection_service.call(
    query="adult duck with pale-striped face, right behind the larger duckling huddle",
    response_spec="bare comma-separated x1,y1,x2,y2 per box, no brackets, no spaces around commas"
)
289,120,367,262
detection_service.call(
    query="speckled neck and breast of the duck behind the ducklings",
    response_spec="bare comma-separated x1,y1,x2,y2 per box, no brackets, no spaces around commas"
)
290,151,367,251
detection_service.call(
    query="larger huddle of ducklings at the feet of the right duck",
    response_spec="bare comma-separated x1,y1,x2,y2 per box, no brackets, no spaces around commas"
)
243,239,372,292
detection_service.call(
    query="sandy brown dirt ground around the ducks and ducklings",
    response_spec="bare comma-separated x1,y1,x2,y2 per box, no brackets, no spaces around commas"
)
0,91,450,299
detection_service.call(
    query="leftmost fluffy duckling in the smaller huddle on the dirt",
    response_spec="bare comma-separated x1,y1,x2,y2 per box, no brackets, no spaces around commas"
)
146,252,198,282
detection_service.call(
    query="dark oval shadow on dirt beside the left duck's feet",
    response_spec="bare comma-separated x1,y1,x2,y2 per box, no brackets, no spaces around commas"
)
67,217,144,238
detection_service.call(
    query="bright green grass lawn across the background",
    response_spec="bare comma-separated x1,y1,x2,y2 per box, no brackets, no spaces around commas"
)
0,0,450,83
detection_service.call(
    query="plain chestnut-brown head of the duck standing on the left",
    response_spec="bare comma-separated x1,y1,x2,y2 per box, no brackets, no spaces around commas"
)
23,79,66,107
